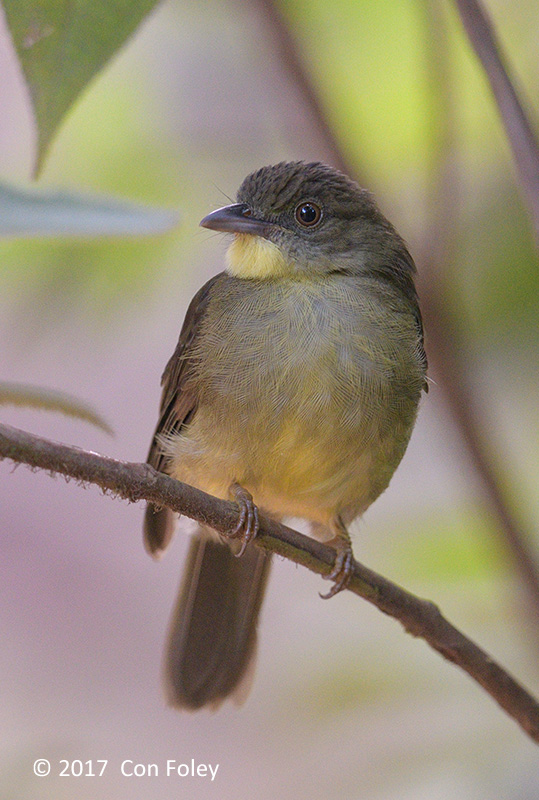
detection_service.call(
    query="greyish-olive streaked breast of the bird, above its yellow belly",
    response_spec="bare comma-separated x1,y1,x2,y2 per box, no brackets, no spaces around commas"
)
194,278,422,428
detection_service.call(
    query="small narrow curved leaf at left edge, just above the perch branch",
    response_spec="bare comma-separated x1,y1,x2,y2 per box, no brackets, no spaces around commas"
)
0,381,113,436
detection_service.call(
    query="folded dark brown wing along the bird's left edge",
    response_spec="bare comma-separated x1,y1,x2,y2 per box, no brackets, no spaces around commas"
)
144,273,223,556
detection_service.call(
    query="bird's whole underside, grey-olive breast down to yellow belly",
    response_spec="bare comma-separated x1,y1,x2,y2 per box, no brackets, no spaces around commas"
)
169,281,422,519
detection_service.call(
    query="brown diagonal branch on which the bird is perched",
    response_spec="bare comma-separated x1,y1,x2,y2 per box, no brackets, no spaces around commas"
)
0,418,539,743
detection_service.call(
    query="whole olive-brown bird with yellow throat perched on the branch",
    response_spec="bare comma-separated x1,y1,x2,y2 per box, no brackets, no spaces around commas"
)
144,161,428,711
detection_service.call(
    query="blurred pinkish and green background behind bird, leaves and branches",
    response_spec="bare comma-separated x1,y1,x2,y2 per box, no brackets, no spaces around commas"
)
0,0,539,800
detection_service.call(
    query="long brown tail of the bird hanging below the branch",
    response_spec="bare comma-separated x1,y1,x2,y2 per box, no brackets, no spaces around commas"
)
165,528,271,710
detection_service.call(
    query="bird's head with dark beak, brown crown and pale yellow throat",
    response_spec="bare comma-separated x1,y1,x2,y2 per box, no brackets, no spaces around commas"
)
200,161,414,280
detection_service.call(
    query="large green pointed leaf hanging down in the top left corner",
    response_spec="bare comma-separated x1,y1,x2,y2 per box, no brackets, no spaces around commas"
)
3,0,162,165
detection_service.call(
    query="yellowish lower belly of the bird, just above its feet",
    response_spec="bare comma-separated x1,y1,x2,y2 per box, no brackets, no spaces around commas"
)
172,371,385,525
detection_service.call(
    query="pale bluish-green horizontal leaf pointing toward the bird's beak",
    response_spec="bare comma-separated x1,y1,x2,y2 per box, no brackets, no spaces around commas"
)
0,182,178,237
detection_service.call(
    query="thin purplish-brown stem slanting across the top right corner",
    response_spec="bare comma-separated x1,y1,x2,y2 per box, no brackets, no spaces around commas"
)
455,0,539,245
